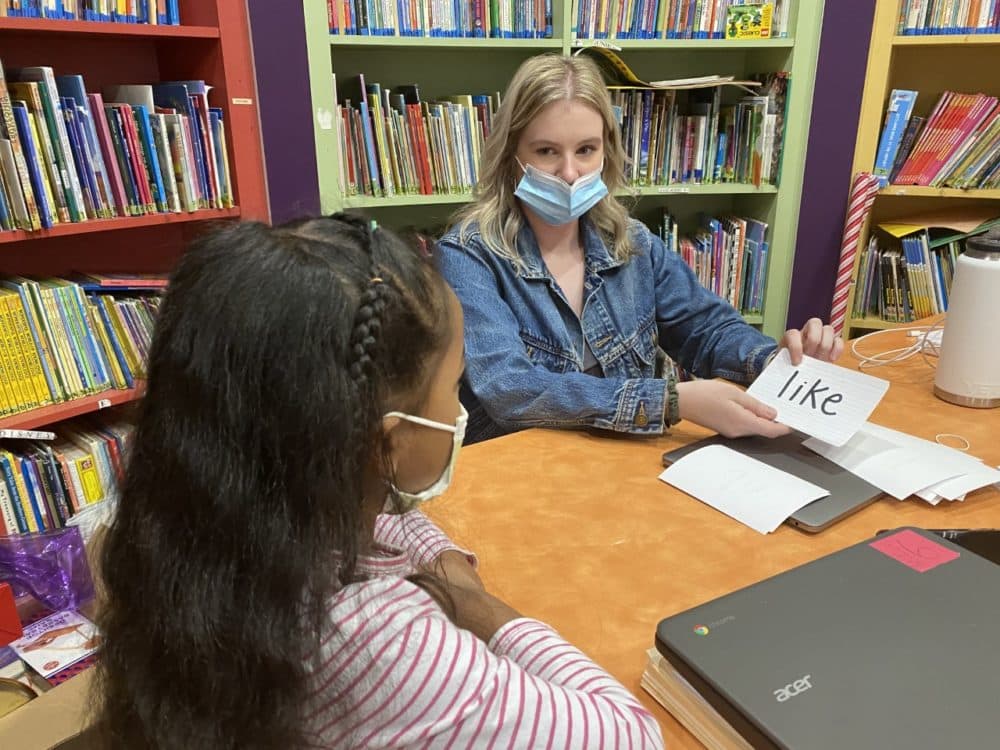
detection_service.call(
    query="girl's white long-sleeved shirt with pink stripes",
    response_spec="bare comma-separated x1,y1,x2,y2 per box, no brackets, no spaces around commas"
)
306,511,663,750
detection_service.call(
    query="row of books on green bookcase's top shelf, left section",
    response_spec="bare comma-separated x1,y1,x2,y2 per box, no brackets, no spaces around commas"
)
326,0,552,39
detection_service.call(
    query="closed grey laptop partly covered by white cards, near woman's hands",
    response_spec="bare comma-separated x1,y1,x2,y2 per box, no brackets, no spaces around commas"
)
663,432,883,533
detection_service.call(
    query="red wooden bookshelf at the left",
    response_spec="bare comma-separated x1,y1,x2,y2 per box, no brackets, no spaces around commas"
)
0,0,268,428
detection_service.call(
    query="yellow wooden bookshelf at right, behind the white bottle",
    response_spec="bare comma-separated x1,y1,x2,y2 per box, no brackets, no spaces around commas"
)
845,0,1000,336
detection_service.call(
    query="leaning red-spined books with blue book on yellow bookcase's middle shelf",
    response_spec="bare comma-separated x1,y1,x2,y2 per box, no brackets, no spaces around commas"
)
874,89,1000,189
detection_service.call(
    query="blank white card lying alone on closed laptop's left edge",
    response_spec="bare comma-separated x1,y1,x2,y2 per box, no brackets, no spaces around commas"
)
660,445,830,534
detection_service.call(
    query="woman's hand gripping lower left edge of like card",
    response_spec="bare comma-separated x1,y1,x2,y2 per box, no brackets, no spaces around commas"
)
677,380,791,438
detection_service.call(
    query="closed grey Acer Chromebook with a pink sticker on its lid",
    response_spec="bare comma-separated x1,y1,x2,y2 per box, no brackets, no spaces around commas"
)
656,528,1000,750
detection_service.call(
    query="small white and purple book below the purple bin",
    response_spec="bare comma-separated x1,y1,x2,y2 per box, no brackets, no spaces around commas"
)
10,610,100,677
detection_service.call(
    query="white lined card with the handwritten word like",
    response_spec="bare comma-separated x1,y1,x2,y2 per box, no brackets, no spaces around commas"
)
747,349,889,446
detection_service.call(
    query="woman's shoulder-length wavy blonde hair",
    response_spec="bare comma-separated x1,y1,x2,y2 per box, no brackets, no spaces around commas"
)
453,53,632,263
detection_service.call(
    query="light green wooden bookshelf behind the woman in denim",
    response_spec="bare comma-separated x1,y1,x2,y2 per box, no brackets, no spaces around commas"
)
303,0,823,337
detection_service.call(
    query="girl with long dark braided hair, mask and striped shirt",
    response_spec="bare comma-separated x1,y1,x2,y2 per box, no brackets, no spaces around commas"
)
95,214,662,750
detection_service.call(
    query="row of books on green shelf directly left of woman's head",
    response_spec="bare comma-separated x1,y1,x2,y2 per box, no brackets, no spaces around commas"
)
337,76,500,197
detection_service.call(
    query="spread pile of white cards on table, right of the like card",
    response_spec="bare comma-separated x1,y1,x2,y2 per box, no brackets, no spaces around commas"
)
803,422,982,500
